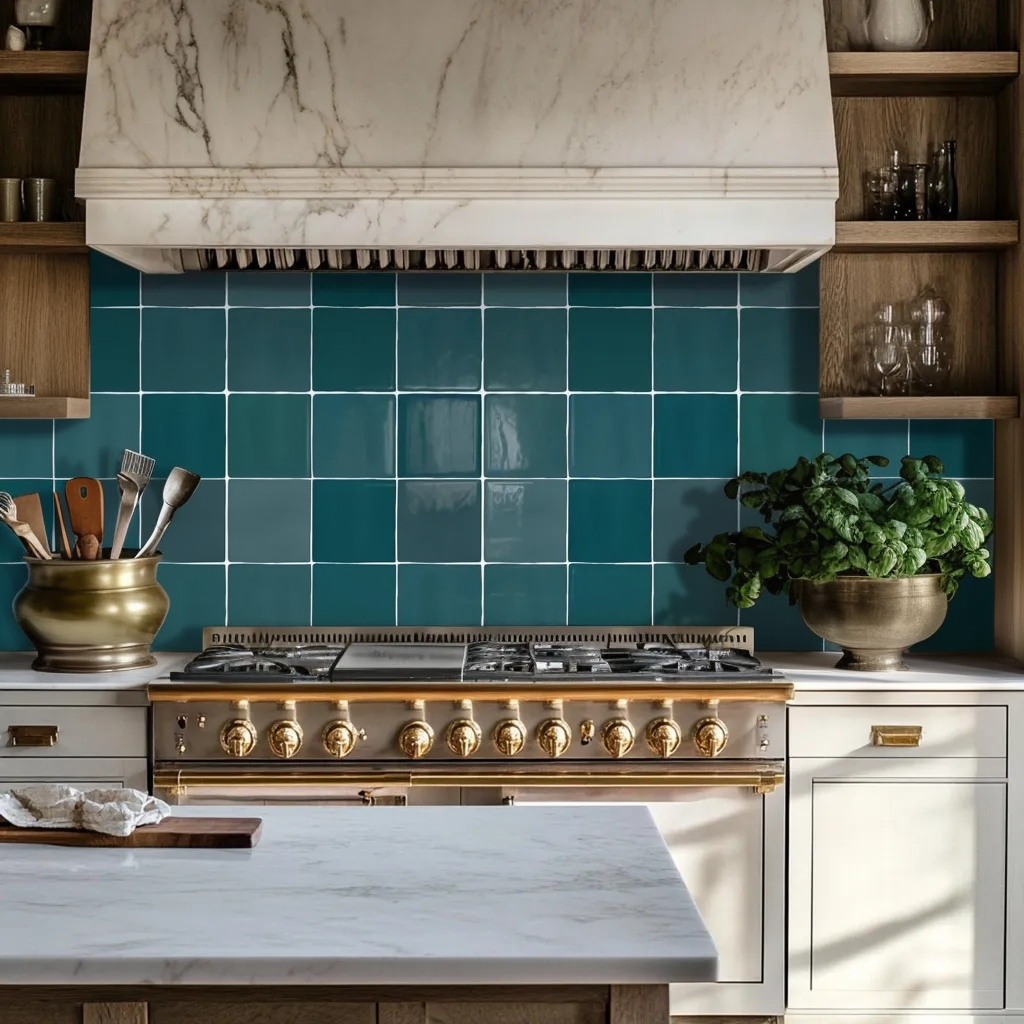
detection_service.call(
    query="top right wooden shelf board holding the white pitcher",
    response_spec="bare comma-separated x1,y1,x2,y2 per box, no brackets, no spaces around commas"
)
828,50,1020,96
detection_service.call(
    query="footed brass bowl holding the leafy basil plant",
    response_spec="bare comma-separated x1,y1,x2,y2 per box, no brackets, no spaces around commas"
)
798,573,948,672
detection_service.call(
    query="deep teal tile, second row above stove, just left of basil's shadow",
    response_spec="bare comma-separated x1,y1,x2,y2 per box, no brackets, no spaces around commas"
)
569,480,651,562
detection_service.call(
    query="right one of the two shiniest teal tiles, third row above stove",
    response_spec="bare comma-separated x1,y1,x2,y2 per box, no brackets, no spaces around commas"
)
483,394,565,477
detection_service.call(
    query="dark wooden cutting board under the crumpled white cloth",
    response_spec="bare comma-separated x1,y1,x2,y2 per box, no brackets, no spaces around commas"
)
0,816,263,850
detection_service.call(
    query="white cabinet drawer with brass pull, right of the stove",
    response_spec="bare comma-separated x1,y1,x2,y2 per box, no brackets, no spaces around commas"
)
788,705,1007,758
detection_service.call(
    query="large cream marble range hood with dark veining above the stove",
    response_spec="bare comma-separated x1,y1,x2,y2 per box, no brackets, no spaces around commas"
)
76,0,838,272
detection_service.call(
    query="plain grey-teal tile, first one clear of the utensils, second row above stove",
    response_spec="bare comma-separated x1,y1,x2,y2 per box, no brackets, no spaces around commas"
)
227,478,312,562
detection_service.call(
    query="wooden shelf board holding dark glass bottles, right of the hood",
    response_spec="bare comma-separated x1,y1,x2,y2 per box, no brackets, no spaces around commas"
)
836,220,1020,253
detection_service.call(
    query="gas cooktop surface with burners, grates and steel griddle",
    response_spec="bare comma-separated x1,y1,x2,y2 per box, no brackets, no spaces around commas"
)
171,641,773,683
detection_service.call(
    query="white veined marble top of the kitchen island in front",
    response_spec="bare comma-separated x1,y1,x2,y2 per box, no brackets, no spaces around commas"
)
0,806,717,985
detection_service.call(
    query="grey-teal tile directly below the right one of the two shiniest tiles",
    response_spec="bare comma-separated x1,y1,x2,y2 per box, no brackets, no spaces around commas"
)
483,480,568,562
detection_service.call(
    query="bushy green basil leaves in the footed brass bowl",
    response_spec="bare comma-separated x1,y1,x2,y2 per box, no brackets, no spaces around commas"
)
684,453,992,608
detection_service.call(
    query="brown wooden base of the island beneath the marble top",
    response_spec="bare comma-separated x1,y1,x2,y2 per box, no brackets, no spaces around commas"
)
0,985,669,1024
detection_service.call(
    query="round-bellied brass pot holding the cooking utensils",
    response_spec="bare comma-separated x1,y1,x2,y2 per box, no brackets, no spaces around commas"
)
13,552,170,672
